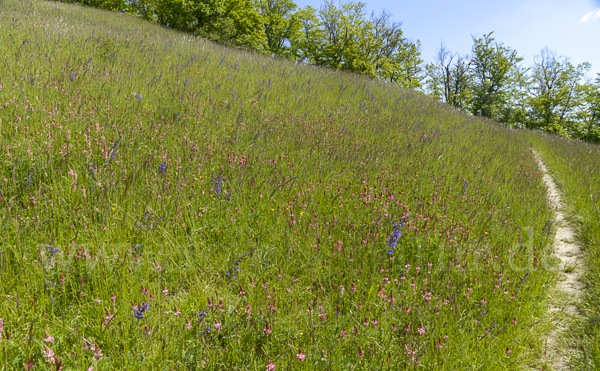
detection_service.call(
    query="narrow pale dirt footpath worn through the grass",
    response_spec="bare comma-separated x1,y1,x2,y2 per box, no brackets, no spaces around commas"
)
532,150,583,371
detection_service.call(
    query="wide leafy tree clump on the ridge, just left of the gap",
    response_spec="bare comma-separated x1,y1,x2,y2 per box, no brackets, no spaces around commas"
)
291,1,423,88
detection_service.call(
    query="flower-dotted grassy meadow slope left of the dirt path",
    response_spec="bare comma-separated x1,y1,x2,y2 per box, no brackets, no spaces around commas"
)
0,0,553,370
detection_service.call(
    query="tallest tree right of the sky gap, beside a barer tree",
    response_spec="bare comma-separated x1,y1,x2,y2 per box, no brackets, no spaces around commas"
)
470,32,526,125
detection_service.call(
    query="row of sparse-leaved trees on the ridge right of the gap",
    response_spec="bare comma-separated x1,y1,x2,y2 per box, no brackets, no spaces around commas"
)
426,40,600,143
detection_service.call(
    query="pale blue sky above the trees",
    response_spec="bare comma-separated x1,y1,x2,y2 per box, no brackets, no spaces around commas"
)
294,0,600,77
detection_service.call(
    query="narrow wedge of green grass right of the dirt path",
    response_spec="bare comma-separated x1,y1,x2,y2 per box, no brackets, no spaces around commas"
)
532,134,600,370
